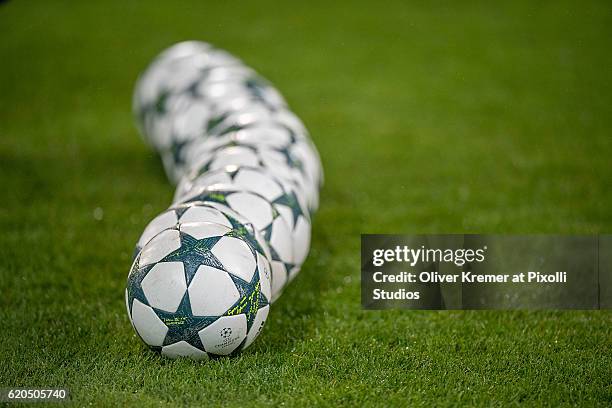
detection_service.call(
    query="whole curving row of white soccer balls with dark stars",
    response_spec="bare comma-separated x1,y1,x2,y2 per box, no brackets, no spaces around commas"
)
125,41,323,359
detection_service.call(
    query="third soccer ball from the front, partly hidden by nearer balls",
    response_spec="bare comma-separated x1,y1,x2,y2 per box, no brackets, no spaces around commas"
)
181,185,299,301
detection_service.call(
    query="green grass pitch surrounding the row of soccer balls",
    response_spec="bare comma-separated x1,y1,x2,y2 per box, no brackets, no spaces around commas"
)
0,1,612,407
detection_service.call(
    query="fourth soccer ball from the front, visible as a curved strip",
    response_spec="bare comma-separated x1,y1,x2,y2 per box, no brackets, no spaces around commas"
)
175,166,311,266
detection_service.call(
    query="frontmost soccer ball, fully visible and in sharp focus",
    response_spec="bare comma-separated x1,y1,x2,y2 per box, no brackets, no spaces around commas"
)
125,222,271,359
